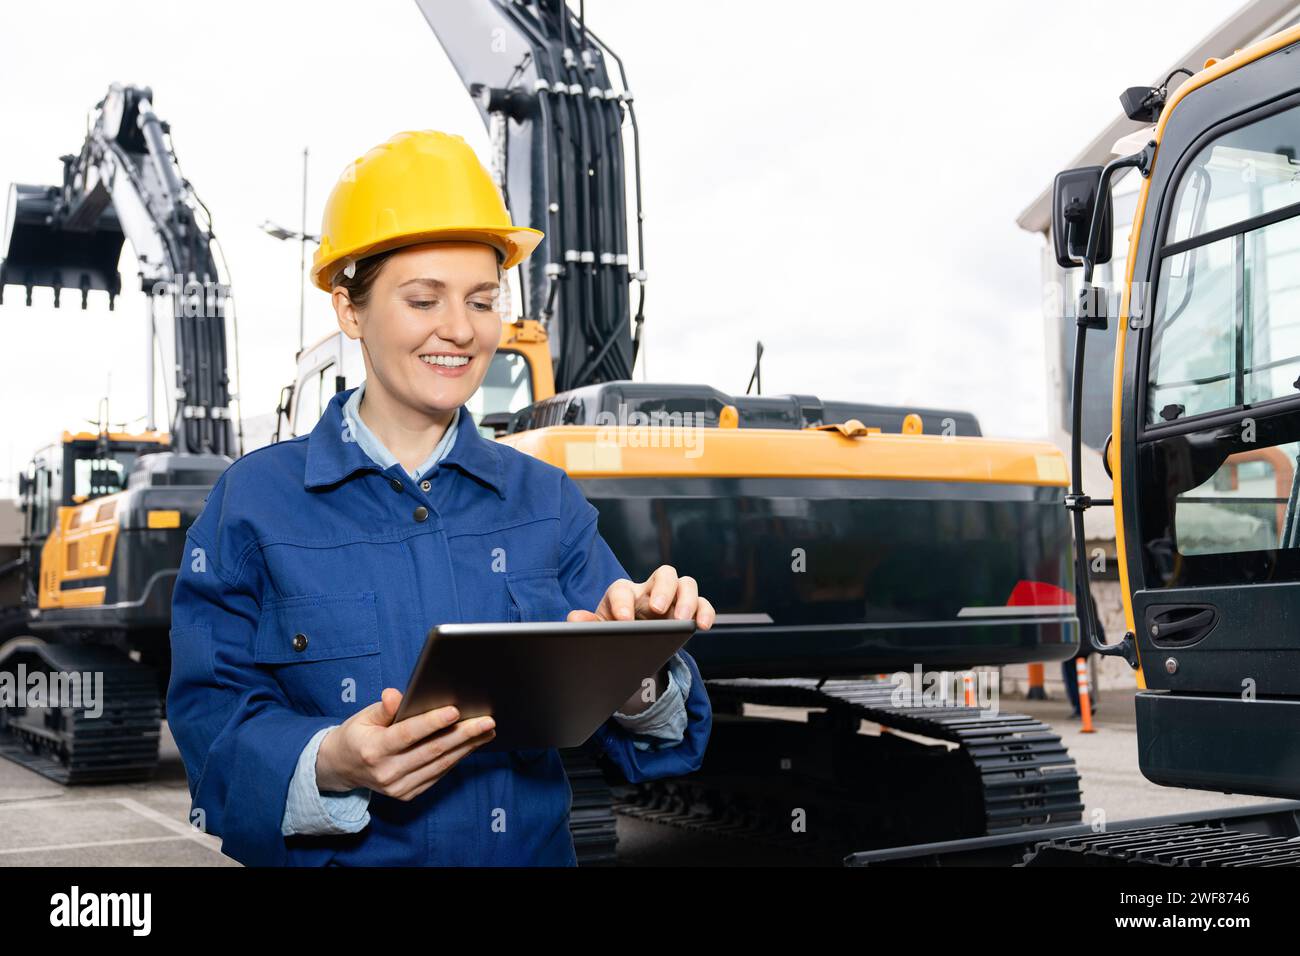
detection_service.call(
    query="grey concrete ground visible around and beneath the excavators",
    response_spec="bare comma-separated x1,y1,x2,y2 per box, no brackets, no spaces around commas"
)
0,691,1289,866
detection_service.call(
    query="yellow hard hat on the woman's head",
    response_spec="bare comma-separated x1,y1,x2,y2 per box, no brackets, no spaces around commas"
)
312,130,543,291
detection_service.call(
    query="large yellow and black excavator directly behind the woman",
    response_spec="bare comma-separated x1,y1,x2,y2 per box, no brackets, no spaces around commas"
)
280,0,1083,864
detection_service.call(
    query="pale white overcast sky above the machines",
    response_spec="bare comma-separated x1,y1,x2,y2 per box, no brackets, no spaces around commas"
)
0,0,1238,494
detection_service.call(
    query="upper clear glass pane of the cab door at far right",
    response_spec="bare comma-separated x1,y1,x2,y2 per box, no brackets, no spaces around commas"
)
1147,100,1300,423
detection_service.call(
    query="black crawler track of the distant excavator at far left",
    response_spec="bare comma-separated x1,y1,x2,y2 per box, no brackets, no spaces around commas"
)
0,639,163,786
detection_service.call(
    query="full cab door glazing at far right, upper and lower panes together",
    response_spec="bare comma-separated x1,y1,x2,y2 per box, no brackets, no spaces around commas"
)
1145,98,1300,584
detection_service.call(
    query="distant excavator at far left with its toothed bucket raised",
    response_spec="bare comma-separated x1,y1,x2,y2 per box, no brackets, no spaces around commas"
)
0,83,237,784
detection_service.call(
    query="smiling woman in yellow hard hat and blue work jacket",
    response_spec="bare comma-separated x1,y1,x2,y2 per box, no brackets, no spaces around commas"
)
168,130,714,865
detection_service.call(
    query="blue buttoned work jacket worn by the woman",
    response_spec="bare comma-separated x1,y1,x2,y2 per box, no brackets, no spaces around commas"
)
168,390,712,866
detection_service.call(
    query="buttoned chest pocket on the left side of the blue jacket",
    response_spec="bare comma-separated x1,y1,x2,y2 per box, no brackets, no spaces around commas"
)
254,591,384,718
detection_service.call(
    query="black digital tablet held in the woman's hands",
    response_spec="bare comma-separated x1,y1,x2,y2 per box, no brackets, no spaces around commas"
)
394,619,696,750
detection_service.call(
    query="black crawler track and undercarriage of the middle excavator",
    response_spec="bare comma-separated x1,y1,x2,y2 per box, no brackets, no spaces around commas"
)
615,679,1083,861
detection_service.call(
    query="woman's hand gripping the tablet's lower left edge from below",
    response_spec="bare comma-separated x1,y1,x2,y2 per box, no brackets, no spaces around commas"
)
316,687,497,800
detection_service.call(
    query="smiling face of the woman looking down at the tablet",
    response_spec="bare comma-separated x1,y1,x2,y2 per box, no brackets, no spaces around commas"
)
334,242,502,412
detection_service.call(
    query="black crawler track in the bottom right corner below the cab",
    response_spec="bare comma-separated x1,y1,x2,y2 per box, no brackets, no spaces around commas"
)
1021,823,1300,868
